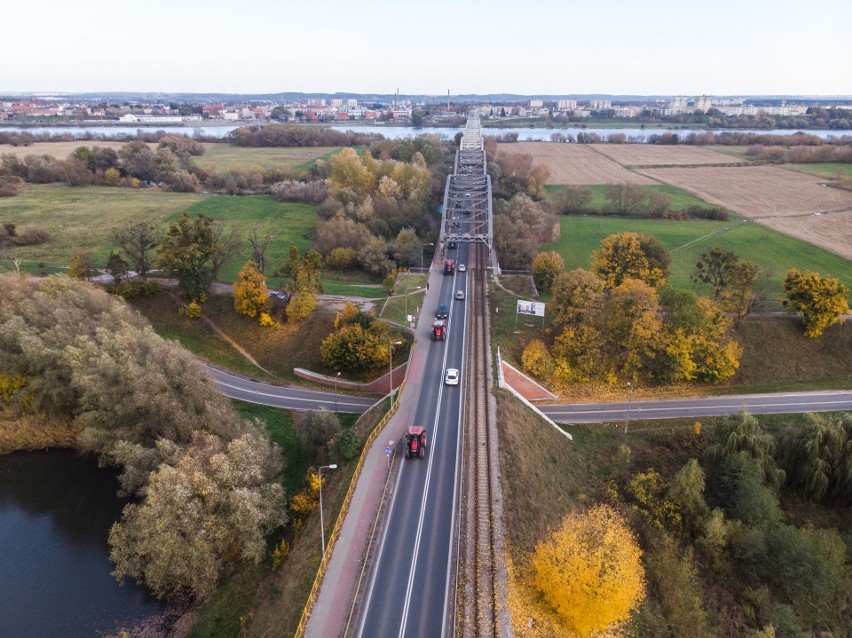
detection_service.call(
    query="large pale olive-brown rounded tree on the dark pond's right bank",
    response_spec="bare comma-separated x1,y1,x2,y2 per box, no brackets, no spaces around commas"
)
109,430,287,600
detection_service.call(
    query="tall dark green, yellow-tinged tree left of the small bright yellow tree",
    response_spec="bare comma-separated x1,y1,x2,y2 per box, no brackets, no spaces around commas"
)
157,213,222,300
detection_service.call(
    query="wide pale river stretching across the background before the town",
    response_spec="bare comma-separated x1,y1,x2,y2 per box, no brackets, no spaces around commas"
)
0,122,852,142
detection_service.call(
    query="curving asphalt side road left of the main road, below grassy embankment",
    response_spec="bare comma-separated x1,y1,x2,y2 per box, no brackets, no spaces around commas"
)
207,366,378,414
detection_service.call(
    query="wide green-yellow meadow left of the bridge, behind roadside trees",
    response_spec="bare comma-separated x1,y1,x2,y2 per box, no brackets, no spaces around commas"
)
0,184,316,282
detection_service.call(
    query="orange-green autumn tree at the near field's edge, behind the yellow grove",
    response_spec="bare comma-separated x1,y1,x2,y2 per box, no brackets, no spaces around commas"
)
592,233,671,289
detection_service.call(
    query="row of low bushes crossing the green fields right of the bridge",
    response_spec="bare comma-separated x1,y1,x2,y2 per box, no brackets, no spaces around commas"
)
550,182,729,221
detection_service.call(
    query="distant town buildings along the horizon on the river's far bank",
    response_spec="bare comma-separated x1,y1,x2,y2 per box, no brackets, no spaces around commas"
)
0,95,850,125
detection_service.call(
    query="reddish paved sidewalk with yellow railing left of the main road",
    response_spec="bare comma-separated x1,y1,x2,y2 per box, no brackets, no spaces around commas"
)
305,268,442,638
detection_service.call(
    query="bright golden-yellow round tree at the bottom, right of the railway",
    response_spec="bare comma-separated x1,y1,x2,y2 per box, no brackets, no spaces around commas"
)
532,505,645,636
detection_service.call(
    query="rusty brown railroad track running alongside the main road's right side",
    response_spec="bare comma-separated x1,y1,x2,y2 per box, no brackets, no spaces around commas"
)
457,245,500,638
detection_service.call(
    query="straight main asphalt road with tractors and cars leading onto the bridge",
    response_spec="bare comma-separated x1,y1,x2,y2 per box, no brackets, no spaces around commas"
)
357,244,467,638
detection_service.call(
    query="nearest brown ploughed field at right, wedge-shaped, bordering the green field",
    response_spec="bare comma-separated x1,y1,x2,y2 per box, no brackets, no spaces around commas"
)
642,166,852,259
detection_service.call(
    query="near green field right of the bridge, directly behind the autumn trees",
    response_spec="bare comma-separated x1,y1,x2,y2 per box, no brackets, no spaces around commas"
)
540,217,852,297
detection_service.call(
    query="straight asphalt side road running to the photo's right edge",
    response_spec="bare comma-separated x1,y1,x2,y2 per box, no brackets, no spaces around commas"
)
538,390,852,423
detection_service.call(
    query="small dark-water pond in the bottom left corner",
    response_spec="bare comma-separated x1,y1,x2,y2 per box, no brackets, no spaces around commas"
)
0,450,167,638
